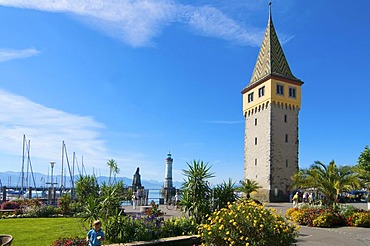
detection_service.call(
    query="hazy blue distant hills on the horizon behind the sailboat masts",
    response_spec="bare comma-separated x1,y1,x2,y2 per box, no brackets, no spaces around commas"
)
0,171,182,189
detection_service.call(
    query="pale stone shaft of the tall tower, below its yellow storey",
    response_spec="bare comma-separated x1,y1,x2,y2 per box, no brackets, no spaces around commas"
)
244,102,299,202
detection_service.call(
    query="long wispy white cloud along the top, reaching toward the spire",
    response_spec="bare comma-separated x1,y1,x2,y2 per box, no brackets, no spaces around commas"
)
0,0,263,47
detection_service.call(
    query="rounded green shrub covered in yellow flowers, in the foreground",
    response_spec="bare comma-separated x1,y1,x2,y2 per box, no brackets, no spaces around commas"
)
198,200,298,246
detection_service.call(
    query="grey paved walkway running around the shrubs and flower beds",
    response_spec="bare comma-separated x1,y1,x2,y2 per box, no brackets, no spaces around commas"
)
125,203,370,246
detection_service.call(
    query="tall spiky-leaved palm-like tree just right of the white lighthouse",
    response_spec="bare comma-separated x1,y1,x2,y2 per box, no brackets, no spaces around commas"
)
180,160,214,223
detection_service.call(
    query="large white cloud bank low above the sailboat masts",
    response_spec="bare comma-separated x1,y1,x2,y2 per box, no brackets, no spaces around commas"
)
0,89,166,179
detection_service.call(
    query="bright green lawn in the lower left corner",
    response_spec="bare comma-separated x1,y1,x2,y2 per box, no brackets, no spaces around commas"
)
0,218,87,246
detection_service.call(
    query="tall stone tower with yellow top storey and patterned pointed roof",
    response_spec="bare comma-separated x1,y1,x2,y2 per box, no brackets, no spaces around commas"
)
242,4,303,202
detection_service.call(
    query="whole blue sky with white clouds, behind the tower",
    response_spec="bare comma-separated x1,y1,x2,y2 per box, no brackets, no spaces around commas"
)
0,0,370,183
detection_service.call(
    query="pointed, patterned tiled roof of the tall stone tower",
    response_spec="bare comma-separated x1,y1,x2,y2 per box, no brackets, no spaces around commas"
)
247,2,299,87
